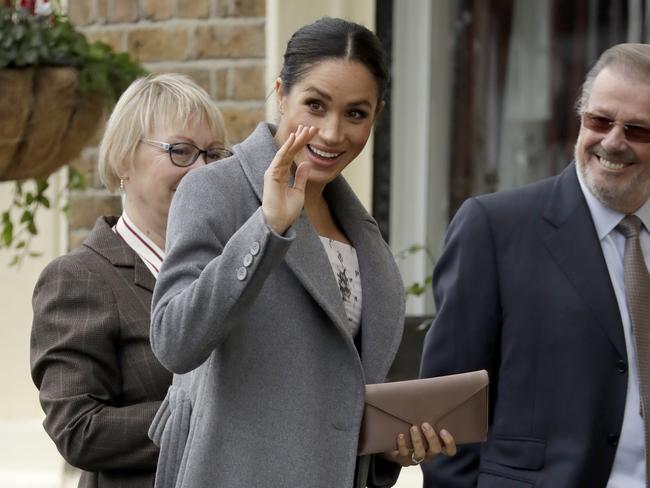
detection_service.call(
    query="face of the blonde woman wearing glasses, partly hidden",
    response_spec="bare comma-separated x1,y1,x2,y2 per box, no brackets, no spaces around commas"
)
124,115,223,244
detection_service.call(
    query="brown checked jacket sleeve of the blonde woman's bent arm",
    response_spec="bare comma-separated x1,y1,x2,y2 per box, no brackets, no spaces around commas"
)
31,257,160,471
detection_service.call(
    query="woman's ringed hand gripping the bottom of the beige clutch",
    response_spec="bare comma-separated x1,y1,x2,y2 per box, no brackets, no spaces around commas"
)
383,422,456,466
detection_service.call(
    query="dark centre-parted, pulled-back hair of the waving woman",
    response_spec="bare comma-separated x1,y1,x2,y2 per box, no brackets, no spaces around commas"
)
280,17,389,100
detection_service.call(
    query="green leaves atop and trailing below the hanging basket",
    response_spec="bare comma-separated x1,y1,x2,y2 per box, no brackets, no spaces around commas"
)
0,2,146,266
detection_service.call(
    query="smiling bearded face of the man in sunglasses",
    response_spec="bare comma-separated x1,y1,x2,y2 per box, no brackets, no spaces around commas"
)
575,68,650,213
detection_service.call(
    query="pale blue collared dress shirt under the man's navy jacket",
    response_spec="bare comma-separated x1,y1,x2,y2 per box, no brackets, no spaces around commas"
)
578,166,650,488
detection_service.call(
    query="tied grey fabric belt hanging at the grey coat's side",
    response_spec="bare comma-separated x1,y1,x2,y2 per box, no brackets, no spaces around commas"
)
149,385,192,488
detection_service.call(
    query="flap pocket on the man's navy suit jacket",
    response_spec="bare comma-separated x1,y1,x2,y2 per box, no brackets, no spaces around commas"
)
481,436,546,470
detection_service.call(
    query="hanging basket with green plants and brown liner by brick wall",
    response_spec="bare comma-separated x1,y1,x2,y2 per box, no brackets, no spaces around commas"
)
0,0,146,265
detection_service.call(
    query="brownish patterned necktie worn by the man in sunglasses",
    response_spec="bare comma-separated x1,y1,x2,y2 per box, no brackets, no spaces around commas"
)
617,215,650,480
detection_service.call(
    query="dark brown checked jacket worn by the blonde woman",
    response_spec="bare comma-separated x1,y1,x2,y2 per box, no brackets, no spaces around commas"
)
31,218,171,488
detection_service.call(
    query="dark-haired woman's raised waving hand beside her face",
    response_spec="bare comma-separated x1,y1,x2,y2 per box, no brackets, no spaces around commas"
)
262,125,318,234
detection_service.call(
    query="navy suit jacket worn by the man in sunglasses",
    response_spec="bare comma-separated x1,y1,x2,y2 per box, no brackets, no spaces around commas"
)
421,165,627,488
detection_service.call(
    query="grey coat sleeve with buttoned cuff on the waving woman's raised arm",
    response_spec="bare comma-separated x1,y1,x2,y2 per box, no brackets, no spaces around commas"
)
151,171,295,374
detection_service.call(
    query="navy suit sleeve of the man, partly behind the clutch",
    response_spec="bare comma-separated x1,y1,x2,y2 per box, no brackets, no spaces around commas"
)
420,199,502,488
